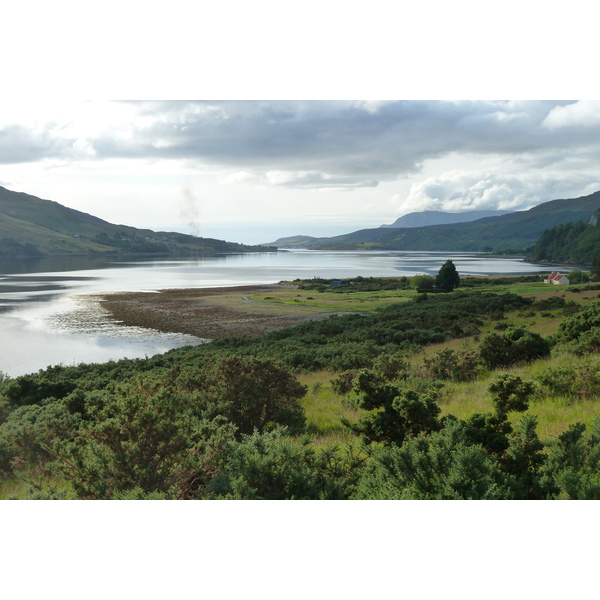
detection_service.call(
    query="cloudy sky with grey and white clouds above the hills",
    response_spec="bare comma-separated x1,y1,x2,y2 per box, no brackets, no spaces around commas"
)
0,100,600,243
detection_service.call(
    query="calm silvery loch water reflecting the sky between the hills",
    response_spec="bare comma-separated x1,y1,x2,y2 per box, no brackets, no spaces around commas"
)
0,250,551,377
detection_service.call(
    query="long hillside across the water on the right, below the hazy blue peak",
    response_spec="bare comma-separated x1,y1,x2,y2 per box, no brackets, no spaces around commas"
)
270,191,600,253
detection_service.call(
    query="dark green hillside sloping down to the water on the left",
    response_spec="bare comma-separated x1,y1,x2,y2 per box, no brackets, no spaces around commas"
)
0,186,274,256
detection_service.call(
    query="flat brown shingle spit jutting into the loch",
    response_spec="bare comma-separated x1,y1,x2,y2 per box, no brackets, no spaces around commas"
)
97,284,352,339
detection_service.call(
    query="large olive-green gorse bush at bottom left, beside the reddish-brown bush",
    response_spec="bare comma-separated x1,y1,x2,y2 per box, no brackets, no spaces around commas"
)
57,385,234,499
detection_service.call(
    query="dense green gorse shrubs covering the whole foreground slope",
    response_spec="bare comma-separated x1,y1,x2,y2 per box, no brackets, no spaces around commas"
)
5,264,600,499
